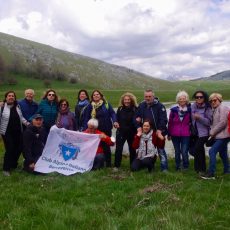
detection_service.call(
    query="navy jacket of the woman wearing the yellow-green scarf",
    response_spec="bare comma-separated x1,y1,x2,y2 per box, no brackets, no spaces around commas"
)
83,103,117,133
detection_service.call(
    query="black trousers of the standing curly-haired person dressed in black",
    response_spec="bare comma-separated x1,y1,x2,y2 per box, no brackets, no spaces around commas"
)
114,131,136,168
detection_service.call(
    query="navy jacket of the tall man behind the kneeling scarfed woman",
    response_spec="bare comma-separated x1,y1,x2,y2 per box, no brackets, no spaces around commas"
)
136,98,168,135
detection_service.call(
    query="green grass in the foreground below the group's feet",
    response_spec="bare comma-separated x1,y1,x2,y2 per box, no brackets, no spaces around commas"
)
0,140,230,230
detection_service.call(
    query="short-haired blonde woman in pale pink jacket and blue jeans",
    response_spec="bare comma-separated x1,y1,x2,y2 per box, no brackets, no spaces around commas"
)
201,93,230,179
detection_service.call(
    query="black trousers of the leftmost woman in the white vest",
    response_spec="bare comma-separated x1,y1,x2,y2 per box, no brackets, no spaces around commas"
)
2,132,22,171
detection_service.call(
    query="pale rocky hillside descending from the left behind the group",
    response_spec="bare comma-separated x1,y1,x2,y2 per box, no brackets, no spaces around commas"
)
0,33,173,89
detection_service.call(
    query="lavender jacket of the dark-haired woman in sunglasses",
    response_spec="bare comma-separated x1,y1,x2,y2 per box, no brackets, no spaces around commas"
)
191,103,212,137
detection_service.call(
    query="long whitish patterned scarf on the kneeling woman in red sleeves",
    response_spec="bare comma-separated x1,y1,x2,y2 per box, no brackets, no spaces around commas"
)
137,130,156,160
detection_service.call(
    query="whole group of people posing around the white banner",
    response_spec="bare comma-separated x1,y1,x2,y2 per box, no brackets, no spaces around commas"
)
0,89,230,179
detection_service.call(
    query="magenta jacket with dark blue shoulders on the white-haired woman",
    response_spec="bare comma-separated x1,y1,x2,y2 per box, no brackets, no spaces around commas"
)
168,106,191,137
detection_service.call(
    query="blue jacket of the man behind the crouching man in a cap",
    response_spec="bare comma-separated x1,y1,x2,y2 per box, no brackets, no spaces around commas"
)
18,98,38,121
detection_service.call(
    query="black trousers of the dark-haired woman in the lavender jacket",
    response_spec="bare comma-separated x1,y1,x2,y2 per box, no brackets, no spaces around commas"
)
194,137,208,172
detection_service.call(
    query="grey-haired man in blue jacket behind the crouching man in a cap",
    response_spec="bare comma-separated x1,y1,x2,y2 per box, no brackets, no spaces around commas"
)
18,89,38,124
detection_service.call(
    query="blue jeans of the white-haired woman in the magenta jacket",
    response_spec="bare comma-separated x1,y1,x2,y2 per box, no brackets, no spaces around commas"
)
172,136,190,170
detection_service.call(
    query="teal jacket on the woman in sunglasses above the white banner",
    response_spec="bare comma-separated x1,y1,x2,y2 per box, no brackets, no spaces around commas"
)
37,99,58,128
